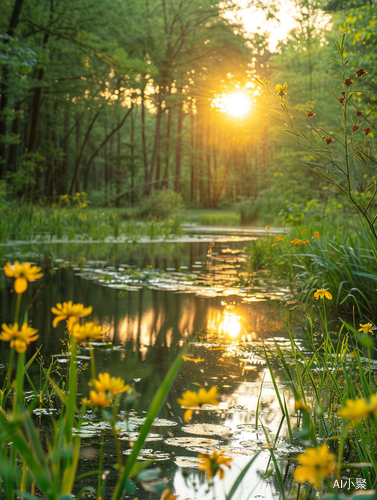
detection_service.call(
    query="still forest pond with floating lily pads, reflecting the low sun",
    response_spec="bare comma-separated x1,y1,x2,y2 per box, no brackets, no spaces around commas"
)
0,237,300,500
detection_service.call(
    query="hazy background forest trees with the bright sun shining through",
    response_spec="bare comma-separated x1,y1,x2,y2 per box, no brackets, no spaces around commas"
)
0,0,377,216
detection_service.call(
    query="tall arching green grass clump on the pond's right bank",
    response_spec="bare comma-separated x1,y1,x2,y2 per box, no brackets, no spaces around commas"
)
248,222,377,317
